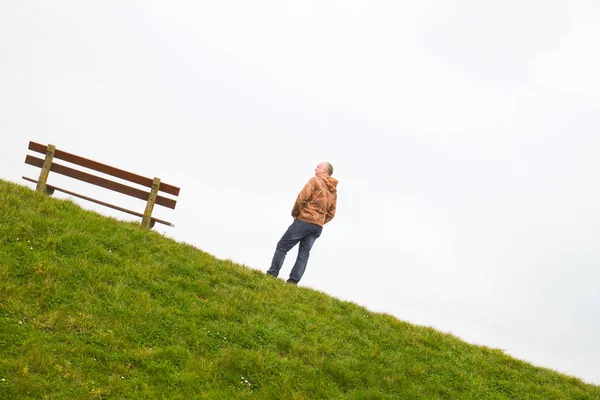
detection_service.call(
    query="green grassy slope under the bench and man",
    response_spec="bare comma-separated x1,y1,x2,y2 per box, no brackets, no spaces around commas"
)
0,181,600,400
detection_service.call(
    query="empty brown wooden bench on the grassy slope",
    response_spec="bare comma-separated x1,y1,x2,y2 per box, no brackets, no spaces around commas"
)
23,142,179,229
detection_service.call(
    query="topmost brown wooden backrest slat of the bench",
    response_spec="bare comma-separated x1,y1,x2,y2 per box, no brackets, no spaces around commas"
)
29,142,180,196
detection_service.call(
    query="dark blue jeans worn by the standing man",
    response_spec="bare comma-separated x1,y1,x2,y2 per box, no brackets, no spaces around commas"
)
267,220,323,283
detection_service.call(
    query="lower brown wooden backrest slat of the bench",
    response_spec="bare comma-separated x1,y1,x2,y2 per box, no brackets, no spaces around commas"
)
25,155,177,209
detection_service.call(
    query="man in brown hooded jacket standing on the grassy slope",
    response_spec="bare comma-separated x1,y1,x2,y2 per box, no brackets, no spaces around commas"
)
267,161,338,285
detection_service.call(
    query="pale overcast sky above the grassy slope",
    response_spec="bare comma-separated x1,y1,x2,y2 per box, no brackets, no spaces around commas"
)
0,0,600,384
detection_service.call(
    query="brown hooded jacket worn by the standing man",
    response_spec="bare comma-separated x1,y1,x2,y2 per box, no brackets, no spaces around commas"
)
292,175,338,226
